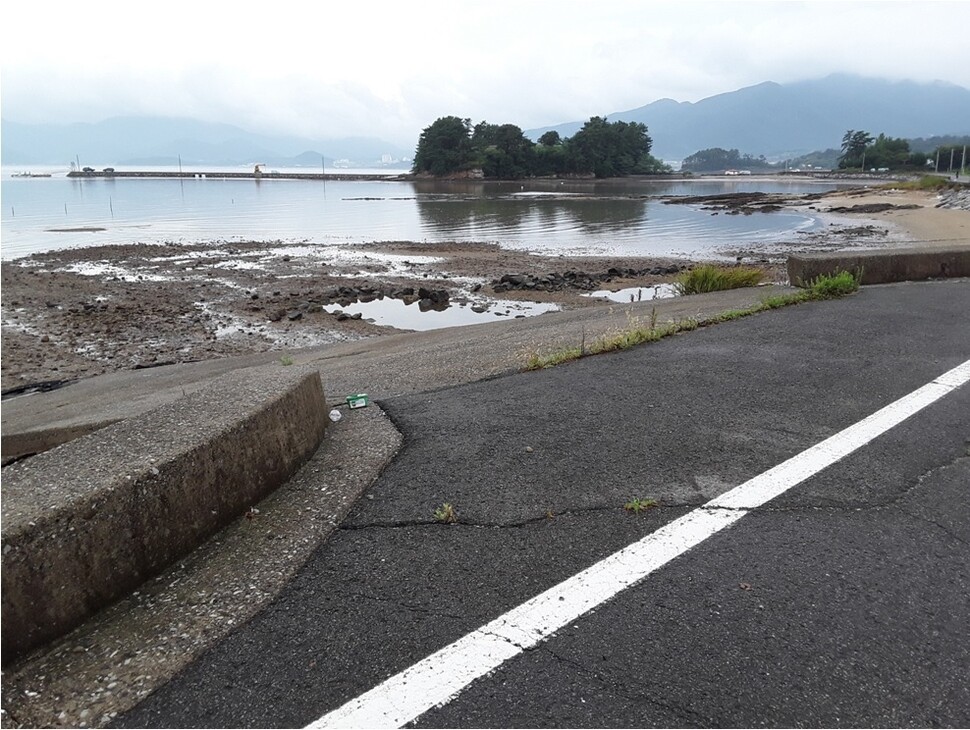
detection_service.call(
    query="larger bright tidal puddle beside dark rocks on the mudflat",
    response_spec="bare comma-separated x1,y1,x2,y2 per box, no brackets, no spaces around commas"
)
324,297,559,330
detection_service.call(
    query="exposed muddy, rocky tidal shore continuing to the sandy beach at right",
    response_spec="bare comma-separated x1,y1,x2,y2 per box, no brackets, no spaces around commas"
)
2,188,970,392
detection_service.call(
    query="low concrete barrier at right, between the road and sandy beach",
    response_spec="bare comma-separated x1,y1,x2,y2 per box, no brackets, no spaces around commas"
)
788,245,970,284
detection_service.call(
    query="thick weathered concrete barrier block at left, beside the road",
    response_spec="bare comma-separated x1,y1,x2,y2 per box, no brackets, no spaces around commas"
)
2,365,328,664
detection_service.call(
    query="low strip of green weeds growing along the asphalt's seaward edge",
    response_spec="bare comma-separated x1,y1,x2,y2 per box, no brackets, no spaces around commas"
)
525,271,862,370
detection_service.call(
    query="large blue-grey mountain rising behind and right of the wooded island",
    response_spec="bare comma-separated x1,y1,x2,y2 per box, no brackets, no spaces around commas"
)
526,75,970,160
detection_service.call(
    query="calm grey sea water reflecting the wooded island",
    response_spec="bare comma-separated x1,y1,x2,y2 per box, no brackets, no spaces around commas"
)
0,167,852,259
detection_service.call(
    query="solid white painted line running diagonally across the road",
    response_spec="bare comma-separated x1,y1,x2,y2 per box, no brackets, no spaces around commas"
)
308,360,970,728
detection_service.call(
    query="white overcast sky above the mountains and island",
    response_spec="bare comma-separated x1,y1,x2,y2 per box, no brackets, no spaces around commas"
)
0,0,970,147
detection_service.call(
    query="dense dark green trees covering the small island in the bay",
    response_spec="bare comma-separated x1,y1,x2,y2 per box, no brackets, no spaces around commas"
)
411,116,671,180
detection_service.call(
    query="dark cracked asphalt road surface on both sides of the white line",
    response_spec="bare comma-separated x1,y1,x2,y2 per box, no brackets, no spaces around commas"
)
115,281,970,727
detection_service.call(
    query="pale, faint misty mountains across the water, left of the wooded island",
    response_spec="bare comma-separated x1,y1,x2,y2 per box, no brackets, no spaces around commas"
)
0,117,414,167
